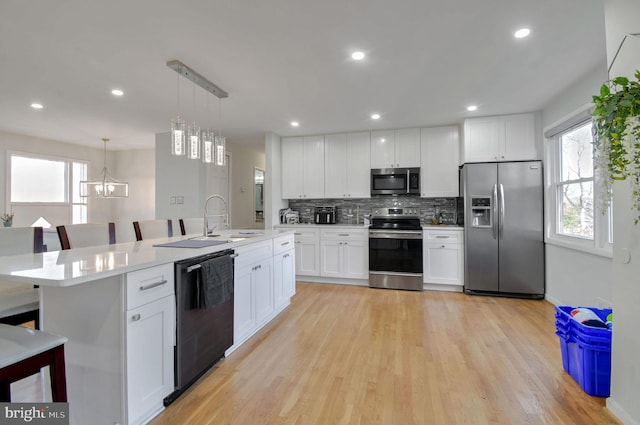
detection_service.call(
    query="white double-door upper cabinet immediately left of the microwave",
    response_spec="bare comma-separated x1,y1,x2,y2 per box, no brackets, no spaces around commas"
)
324,132,371,199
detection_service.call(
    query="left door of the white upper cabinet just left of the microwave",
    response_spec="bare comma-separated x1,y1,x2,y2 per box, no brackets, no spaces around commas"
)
324,134,350,199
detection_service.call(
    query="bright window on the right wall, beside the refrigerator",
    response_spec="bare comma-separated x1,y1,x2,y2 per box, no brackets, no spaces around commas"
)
546,119,613,252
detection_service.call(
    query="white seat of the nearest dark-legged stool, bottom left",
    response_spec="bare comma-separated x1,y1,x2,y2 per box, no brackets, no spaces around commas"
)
0,324,67,369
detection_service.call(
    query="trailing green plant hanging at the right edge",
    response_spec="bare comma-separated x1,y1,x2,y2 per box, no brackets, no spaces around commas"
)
593,70,640,224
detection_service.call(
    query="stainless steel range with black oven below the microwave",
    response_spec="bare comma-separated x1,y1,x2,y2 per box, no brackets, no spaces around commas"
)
369,208,423,291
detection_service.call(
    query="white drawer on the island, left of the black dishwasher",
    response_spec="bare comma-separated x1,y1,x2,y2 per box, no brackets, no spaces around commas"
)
126,263,174,310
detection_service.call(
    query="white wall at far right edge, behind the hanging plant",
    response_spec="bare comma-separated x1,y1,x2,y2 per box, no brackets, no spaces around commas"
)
605,0,640,425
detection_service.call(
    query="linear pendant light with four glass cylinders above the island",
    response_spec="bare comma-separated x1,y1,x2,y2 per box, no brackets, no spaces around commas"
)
167,60,229,166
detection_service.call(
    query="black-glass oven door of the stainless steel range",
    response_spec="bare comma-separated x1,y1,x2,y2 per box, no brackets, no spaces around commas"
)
369,230,422,276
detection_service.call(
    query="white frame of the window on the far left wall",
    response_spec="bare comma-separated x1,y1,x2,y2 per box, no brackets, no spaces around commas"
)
5,150,90,224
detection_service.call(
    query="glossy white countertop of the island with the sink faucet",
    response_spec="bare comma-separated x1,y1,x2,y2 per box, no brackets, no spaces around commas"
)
0,229,286,287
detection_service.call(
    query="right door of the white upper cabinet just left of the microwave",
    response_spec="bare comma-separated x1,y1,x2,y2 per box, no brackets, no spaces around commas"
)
348,132,371,198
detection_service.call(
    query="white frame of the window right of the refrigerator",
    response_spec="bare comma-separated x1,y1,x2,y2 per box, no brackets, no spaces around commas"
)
545,110,613,258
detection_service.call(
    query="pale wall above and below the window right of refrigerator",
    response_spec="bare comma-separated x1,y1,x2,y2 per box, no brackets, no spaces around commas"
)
542,61,613,307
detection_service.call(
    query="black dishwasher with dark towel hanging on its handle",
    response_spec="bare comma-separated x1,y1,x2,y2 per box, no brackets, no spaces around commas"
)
164,250,235,406
